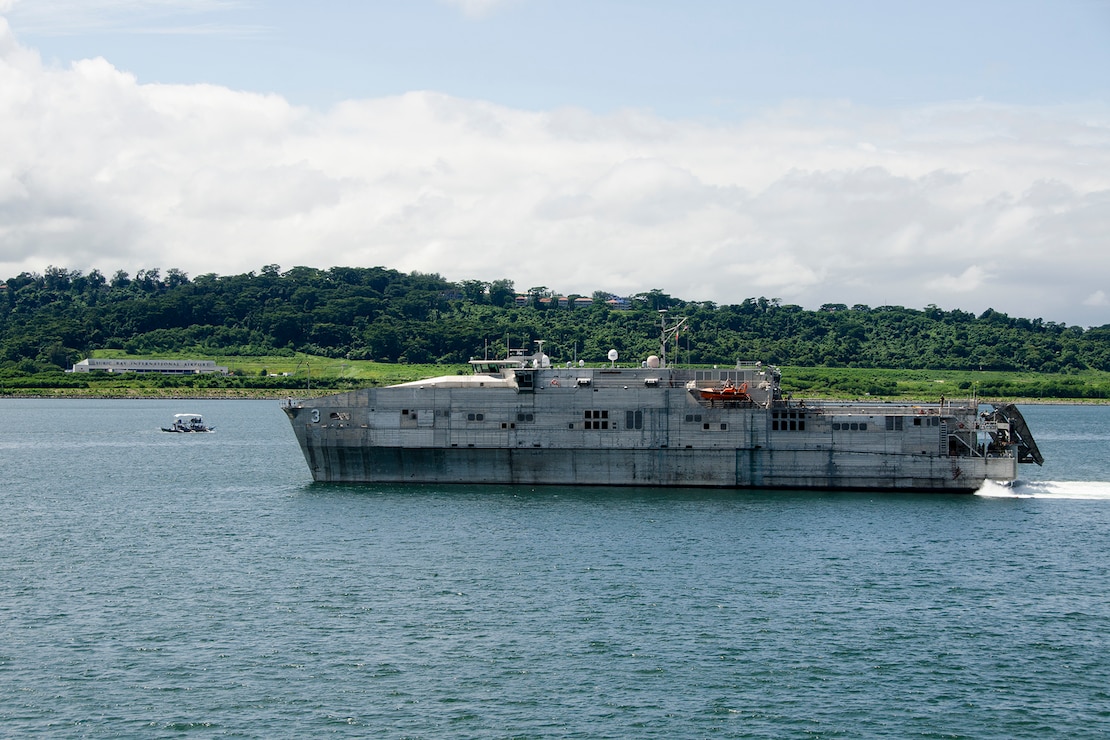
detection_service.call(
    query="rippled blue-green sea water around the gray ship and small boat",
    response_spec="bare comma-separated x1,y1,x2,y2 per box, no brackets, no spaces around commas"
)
0,399,1110,739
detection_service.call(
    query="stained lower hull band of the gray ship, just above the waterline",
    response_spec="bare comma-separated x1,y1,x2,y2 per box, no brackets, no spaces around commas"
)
290,438,1016,493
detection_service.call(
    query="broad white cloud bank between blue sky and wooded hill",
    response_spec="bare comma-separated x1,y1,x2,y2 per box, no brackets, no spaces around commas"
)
0,19,1110,325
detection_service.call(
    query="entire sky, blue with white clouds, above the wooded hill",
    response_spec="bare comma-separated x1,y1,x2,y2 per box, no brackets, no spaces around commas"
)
0,0,1110,327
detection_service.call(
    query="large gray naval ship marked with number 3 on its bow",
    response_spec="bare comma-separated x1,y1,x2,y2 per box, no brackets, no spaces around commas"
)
283,326,1043,493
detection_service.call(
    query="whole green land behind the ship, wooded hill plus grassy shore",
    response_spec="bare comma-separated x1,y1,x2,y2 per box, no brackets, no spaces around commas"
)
0,265,1110,403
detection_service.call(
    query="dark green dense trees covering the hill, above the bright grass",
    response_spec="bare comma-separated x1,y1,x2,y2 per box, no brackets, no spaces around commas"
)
0,265,1110,388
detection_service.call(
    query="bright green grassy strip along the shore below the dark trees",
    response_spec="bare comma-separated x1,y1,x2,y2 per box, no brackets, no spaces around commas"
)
0,351,1110,404
